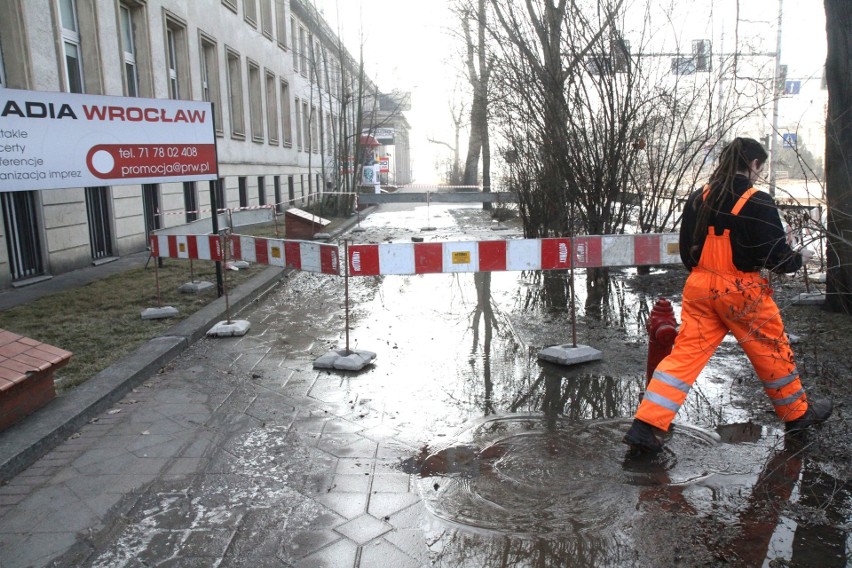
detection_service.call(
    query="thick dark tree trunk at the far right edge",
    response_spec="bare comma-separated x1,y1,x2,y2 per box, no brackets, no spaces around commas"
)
825,0,852,313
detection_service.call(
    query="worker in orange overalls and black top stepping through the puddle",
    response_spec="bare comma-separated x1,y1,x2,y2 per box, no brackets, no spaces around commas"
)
623,138,832,453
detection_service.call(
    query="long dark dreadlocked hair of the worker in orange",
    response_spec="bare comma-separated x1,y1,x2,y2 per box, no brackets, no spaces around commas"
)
690,138,769,260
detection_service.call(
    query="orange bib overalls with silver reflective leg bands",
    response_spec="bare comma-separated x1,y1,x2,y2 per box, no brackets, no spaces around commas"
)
636,187,808,430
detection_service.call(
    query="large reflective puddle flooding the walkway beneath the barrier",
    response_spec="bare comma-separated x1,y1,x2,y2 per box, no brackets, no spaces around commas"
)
336,206,852,566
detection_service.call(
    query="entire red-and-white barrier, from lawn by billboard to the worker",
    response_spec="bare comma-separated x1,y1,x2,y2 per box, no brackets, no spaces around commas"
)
151,233,680,276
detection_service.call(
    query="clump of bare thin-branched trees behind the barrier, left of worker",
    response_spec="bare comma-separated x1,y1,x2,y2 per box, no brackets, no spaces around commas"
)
480,0,773,310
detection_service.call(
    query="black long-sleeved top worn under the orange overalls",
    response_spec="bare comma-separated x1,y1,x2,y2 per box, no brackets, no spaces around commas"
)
680,175,802,272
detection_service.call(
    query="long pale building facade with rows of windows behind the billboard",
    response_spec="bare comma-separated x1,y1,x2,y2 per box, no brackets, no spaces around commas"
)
0,0,410,288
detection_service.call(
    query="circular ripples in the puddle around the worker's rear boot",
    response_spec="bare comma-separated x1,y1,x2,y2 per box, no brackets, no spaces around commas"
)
412,416,715,538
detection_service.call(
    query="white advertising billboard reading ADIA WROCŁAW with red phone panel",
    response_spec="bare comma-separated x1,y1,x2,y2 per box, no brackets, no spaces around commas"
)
0,89,218,191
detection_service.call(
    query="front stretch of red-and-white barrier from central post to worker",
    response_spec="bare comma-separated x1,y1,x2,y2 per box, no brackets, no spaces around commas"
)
349,233,680,276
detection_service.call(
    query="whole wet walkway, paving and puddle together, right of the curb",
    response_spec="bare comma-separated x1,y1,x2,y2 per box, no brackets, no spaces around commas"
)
0,197,848,568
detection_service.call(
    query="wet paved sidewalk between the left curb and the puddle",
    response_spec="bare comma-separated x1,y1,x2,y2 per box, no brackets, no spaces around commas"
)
0,273,429,568
